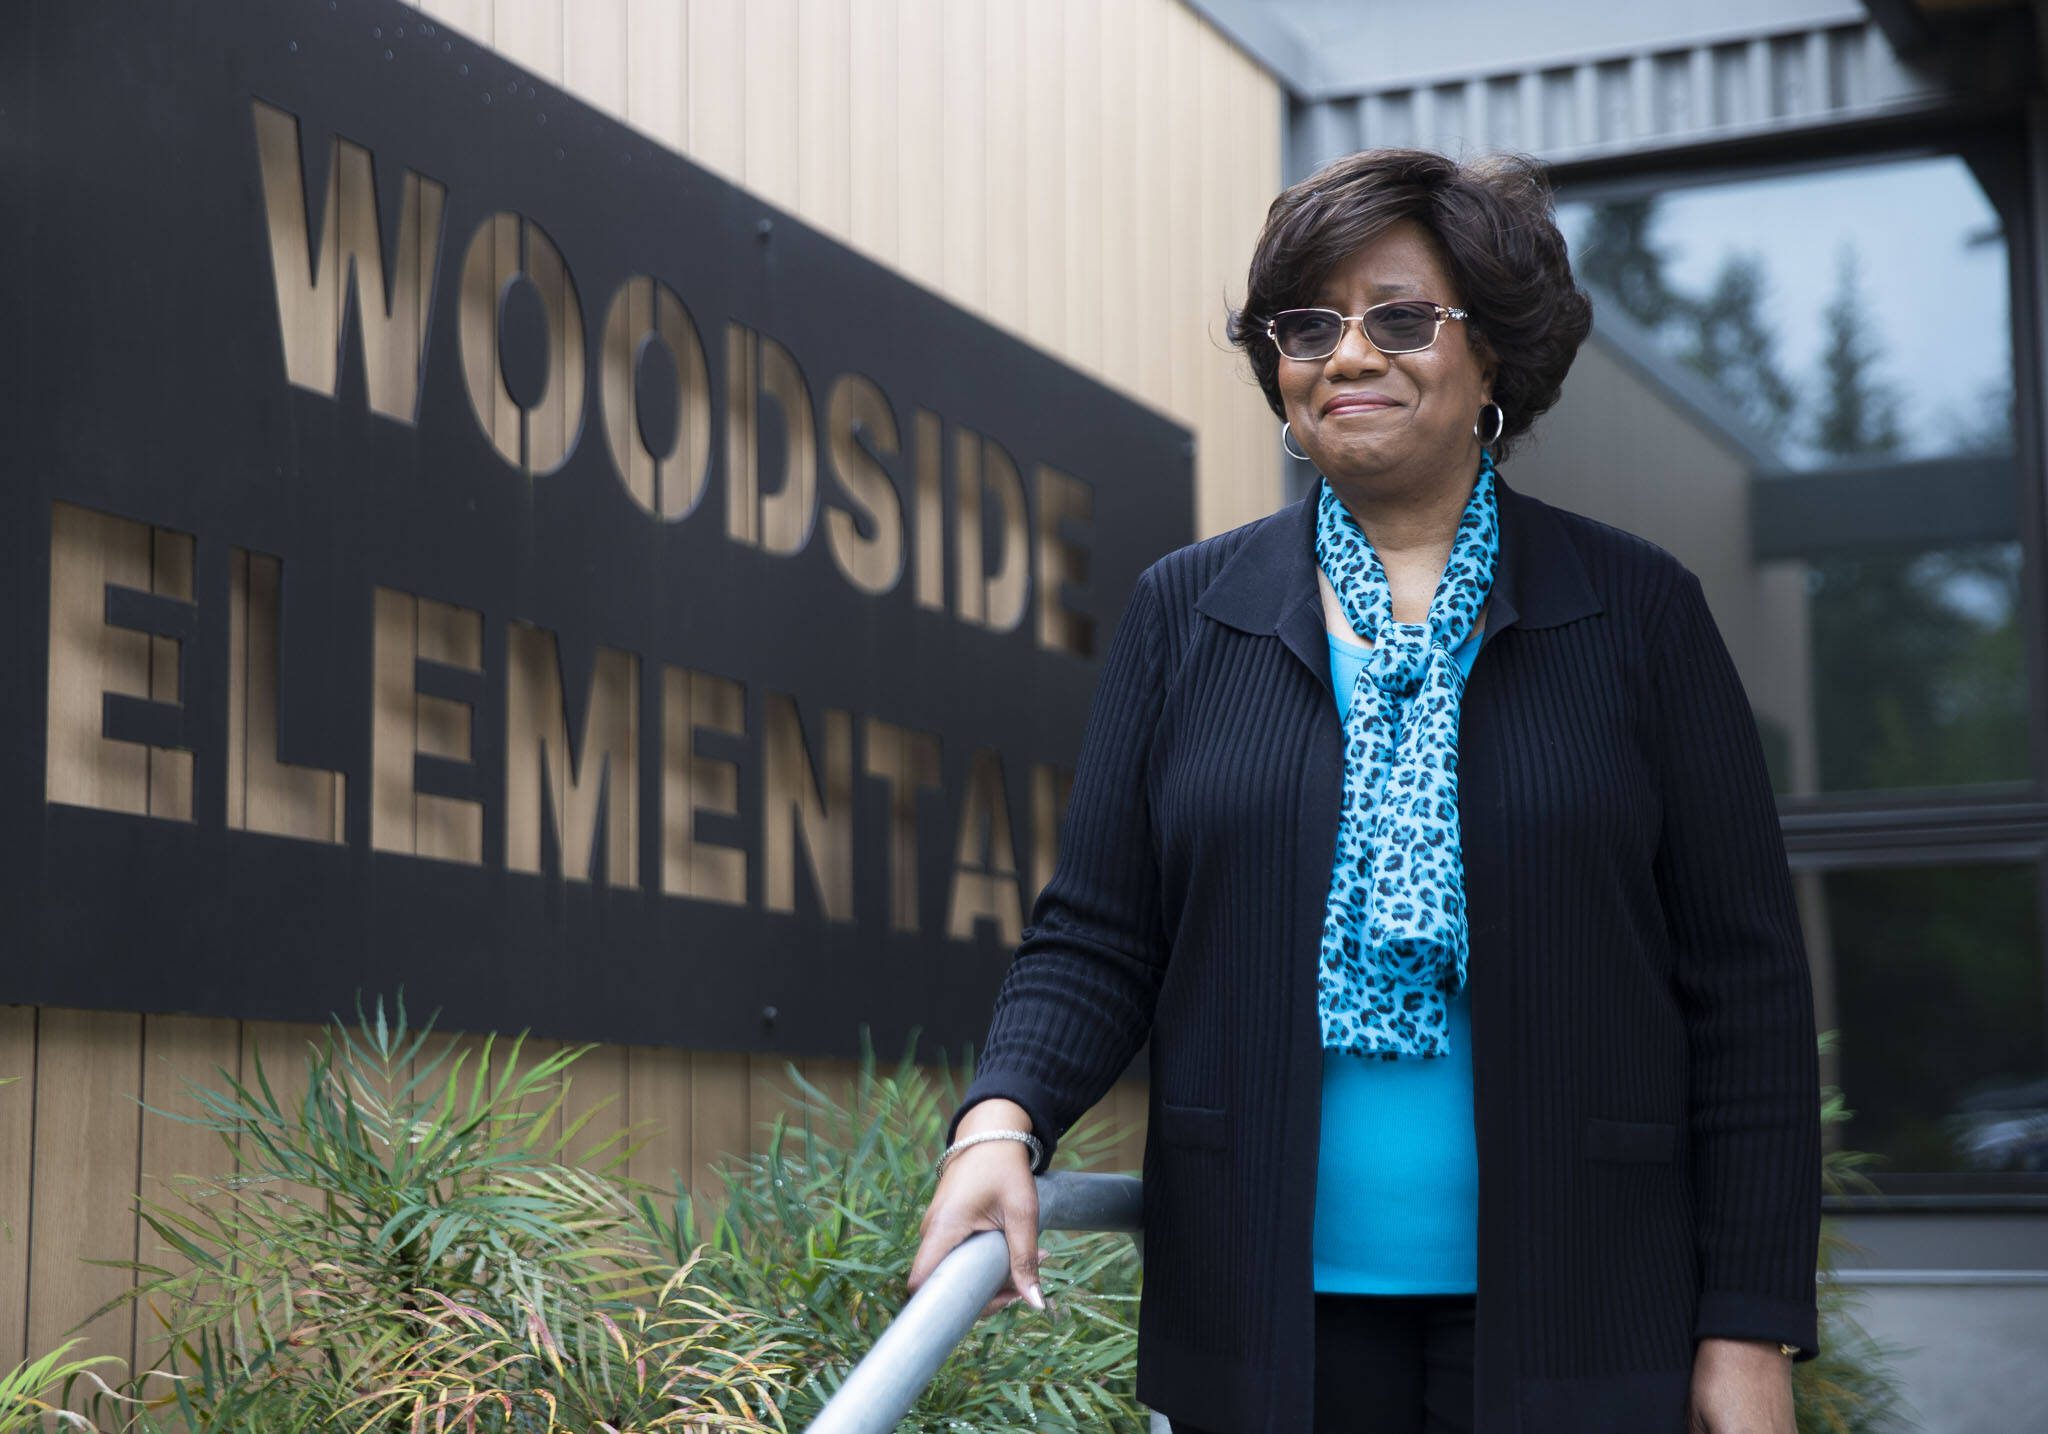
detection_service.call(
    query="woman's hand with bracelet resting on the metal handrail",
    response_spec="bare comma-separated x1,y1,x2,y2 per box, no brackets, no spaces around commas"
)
909,1100,1047,1315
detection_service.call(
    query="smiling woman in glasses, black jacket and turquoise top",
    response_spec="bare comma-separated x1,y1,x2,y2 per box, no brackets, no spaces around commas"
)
909,150,1821,1434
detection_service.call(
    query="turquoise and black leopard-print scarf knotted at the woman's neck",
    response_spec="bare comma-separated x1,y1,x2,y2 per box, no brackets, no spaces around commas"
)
1315,453,1501,1061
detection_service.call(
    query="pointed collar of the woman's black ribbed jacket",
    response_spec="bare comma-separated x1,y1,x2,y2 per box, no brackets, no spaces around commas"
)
1194,458,1604,690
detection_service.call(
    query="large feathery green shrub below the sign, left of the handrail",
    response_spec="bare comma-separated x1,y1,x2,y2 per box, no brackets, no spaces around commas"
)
92,1002,780,1434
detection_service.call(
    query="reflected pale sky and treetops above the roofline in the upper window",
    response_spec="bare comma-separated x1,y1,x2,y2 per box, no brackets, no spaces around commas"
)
1559,156,2013,469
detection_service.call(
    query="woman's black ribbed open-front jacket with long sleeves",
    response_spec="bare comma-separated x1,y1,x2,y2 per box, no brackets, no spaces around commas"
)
952,481,1821,1434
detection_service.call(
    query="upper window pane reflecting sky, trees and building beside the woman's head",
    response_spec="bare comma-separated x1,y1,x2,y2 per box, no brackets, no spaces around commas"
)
1509,156,2030,797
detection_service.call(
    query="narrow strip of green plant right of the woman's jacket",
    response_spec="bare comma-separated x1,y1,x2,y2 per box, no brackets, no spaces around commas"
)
1792,1030,1911,1434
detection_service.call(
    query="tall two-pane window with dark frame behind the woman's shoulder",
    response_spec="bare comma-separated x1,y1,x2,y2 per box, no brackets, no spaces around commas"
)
1540,154,2048,1194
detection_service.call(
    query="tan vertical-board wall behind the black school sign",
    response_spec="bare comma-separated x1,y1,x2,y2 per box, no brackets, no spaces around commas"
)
0,0,1282,1393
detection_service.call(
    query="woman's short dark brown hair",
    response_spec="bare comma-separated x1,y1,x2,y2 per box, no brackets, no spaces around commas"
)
1229,150,1593,459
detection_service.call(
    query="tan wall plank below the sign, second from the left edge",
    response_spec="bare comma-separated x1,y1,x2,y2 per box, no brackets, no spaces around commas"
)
29,1008,141,1384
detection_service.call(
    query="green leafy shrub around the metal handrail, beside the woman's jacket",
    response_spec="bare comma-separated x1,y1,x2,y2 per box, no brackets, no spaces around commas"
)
641,1030,1145,1434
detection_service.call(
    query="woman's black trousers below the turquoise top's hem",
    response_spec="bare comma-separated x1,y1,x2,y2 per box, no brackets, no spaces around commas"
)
1174,1295,1477,1434
